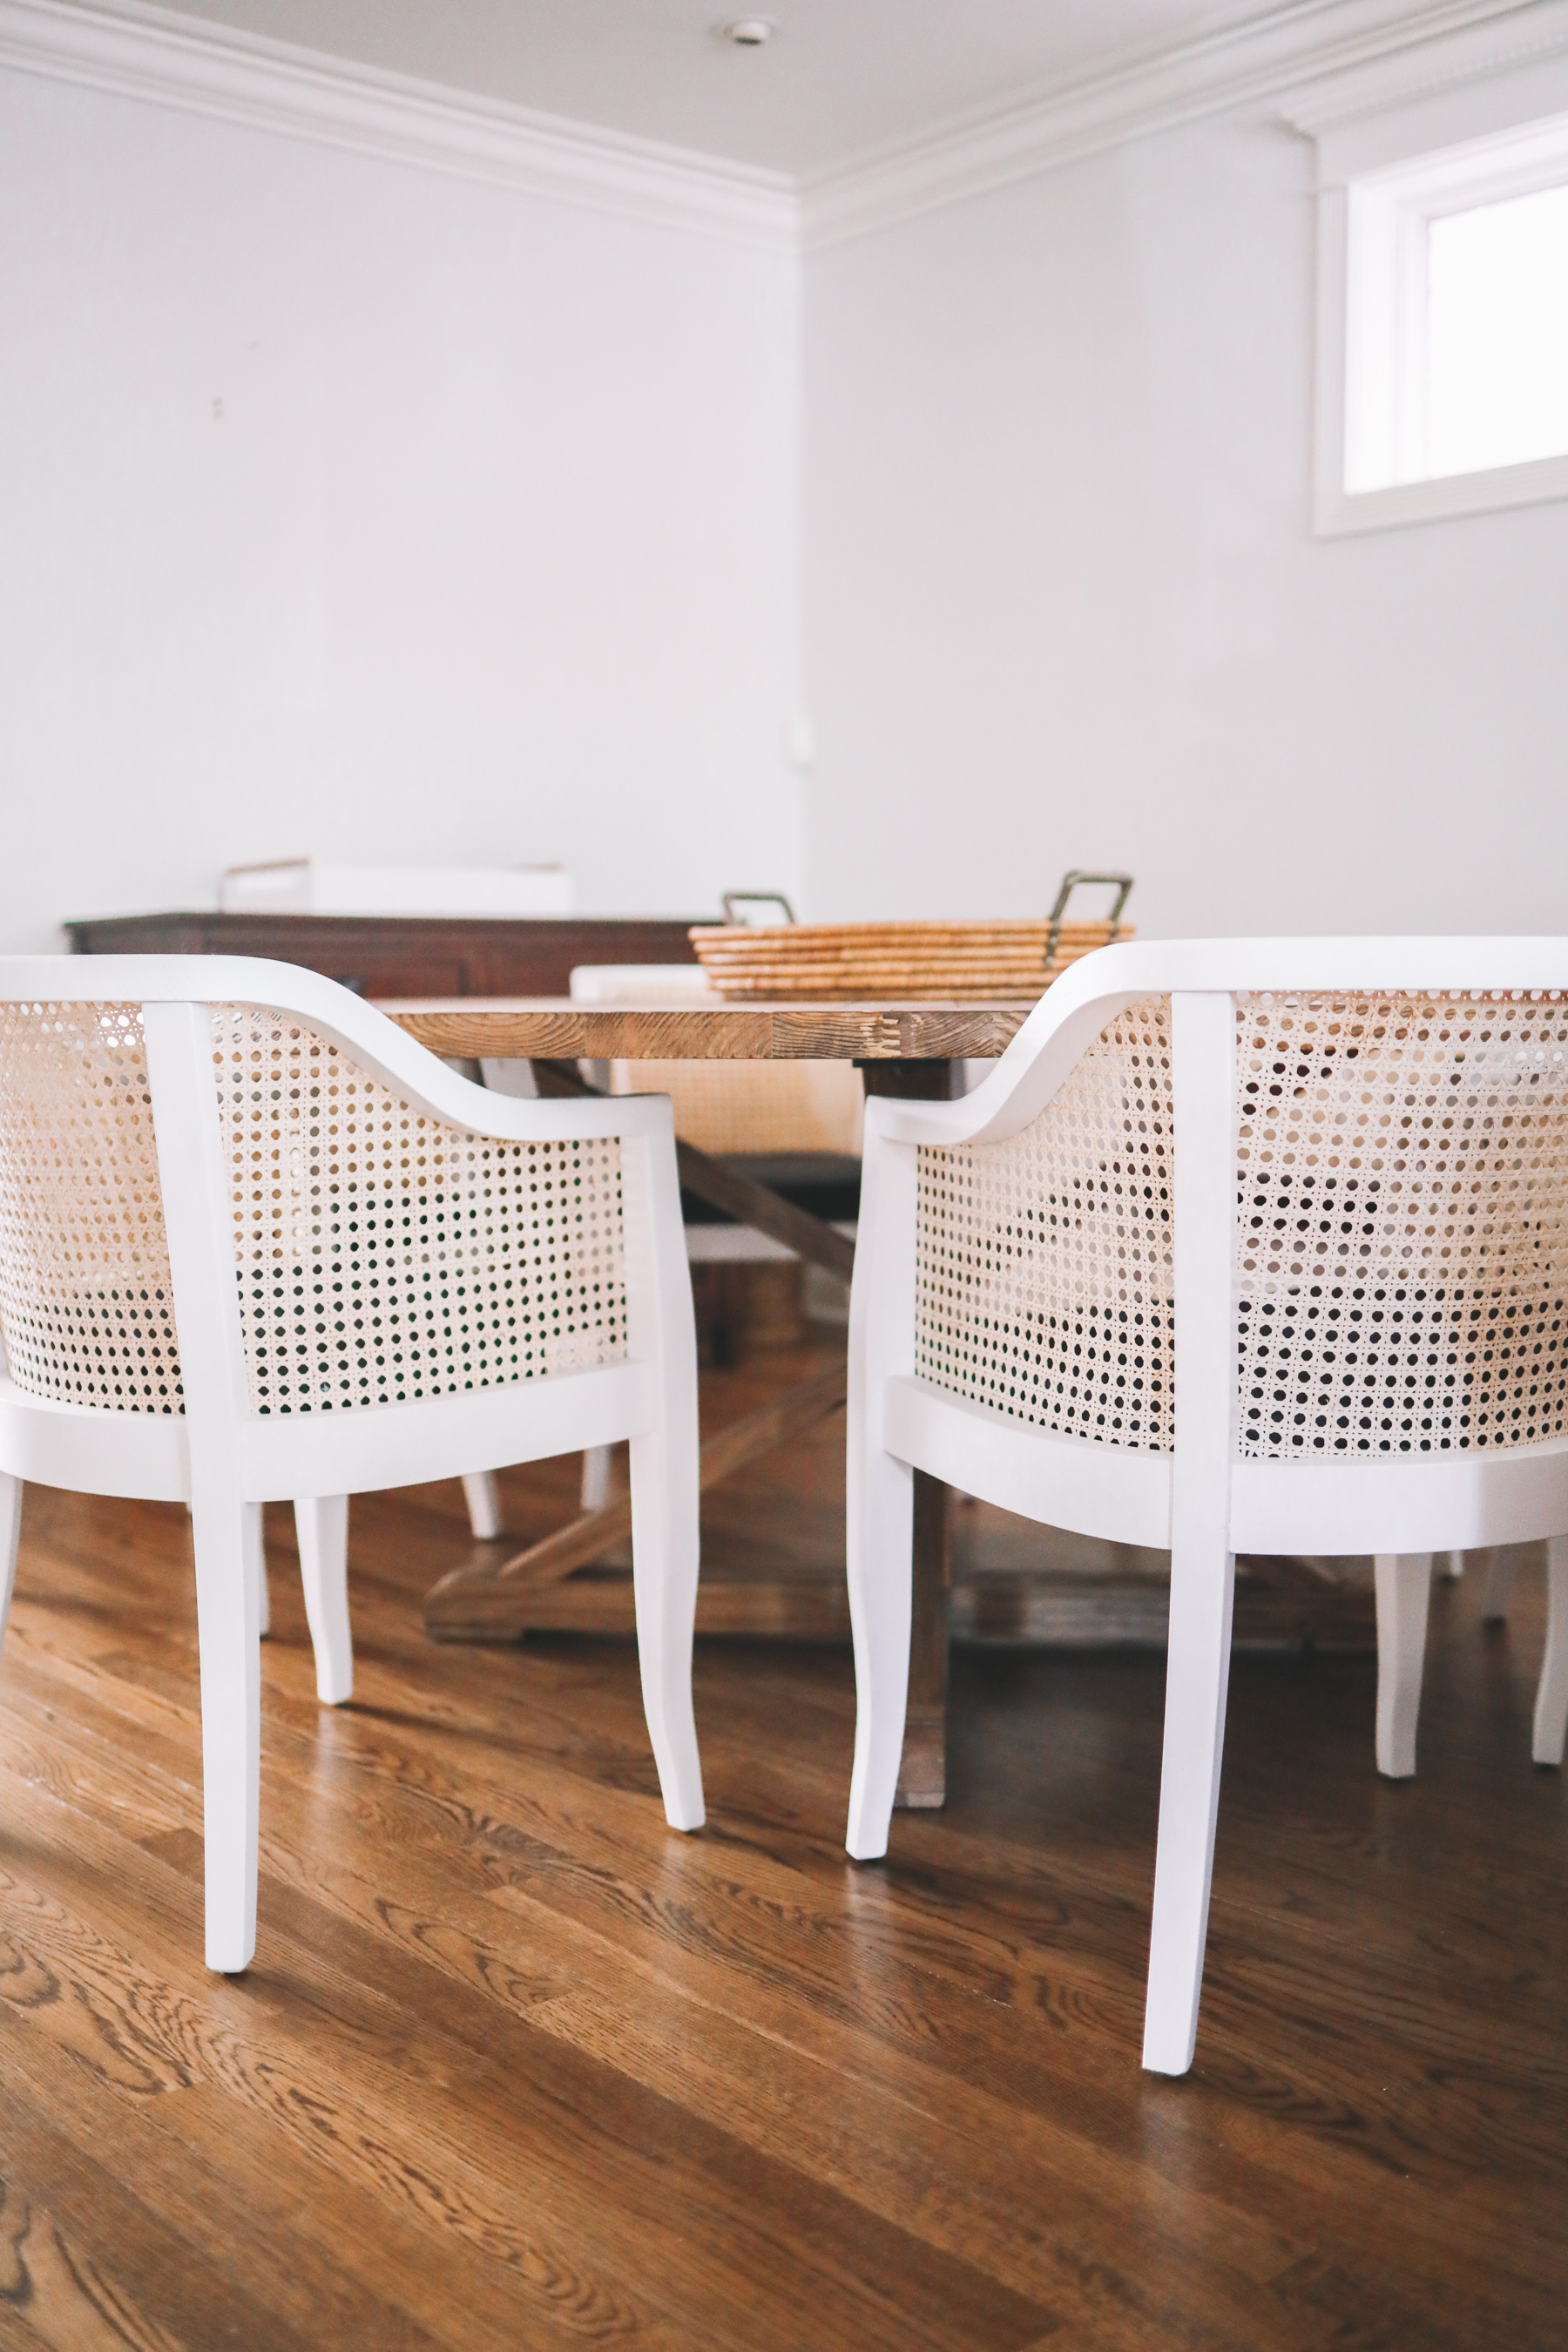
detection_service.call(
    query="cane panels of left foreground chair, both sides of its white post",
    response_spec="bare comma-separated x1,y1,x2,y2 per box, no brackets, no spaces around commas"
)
0,1004,625,1414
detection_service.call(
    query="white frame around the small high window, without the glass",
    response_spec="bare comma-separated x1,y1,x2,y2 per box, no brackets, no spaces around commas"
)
1288,37,1568,538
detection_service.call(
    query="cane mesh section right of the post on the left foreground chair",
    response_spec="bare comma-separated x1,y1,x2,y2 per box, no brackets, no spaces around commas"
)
212,1007,625,1414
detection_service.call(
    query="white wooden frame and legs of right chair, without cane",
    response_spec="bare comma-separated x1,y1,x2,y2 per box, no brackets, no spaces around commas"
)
847,938,1568,2074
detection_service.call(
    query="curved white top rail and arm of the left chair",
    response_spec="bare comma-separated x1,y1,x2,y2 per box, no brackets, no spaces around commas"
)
0,955,670,1143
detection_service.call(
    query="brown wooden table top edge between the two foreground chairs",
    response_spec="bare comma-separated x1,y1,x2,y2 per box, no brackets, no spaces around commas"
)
381,997,1034,1061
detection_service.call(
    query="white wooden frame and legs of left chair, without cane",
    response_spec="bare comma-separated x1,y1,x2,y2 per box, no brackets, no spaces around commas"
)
0,957,703,1971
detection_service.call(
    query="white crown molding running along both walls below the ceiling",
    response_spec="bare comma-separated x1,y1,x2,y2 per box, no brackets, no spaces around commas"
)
0,0,1568,252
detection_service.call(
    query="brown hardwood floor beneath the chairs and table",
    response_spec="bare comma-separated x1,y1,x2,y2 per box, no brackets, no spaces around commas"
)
0,1367,1568,2352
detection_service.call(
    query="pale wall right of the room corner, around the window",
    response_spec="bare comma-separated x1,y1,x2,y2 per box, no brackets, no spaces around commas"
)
804,120,1568,934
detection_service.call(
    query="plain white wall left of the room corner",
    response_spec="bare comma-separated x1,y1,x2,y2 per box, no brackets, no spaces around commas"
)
0,73,801,948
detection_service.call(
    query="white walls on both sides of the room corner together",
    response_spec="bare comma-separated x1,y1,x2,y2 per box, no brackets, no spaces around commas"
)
0,73,1568,948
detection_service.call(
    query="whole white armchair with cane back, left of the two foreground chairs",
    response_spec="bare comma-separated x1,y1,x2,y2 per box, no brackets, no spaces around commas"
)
0,955,703,1971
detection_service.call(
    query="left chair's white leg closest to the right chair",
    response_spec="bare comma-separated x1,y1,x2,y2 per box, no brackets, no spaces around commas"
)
632,1428,707,1830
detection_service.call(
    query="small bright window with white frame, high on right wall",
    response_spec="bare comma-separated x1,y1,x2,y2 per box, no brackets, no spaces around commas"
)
1295,47,1568,534
